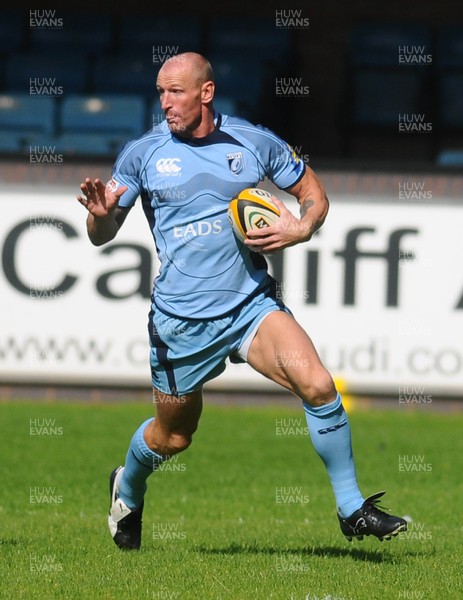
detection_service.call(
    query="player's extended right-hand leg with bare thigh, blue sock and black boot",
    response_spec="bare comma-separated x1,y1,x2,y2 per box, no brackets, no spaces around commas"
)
247,311,406,539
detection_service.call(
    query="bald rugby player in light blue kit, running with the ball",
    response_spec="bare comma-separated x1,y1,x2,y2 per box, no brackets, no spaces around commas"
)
77,52,407,550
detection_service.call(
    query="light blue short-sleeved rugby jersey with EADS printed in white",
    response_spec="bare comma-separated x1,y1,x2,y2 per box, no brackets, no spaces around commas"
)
112,115,305,319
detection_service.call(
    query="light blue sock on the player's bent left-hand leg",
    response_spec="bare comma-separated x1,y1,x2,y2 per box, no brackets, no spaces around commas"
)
119,418,170,510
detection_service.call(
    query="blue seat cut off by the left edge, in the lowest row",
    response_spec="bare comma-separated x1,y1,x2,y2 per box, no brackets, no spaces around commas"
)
0,94,56,152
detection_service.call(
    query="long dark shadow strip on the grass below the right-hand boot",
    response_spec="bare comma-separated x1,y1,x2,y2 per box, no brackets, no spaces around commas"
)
195,542,432,563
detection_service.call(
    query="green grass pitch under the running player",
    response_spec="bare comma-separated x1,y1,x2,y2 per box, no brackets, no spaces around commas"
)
0,398,463,600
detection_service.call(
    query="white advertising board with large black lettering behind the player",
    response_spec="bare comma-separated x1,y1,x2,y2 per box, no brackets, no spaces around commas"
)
0,169,463,401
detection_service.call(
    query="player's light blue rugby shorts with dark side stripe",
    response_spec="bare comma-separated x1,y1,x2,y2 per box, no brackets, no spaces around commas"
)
148,286,290,395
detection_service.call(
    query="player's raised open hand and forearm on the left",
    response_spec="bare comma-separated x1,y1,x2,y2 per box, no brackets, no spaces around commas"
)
77,177,130,246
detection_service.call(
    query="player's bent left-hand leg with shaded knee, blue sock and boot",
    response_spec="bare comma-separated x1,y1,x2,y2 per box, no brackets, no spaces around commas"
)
108,389,202,549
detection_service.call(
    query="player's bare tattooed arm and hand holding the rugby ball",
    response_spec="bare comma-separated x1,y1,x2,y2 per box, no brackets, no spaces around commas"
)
245,166,329,253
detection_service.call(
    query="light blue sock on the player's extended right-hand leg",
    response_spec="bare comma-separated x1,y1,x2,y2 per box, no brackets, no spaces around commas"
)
303,394,364,517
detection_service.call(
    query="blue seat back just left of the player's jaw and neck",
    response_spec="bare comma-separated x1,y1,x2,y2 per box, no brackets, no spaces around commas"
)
60,94,146,140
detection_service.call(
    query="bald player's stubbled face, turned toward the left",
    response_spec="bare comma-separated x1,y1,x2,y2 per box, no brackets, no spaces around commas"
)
156,62,202,137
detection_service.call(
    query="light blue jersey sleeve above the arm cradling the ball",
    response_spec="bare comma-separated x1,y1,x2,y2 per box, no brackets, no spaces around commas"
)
256,125,305,189
